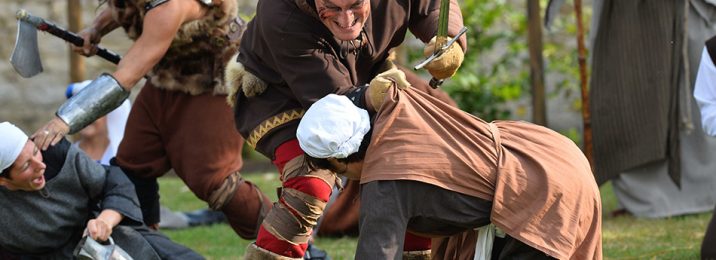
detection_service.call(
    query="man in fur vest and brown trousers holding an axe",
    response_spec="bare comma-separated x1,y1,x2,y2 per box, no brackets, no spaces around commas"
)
34,0,271,239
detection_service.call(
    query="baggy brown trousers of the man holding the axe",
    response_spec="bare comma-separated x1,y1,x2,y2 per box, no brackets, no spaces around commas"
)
117,83,271,238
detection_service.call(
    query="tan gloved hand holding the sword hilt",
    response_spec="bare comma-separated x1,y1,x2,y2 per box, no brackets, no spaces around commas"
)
423,37,465,79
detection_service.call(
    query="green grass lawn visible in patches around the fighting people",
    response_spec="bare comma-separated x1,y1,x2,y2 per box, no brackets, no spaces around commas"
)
160,172,711,259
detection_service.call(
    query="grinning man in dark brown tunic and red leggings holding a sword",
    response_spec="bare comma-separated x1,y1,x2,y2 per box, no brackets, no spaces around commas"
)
227,0,466,259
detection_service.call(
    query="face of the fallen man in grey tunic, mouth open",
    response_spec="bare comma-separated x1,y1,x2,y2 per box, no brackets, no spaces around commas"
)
0,140,47,191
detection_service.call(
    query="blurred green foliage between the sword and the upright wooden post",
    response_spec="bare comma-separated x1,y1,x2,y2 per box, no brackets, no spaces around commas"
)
444,0,529,120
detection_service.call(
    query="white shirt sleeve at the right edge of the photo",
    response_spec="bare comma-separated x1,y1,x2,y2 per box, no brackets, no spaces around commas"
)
694,48,716,136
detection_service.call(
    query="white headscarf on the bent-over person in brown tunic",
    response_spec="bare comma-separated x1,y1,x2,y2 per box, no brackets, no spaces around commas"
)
296,94,370,159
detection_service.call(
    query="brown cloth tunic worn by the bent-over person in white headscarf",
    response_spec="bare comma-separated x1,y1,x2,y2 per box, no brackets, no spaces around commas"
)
361,89,602,259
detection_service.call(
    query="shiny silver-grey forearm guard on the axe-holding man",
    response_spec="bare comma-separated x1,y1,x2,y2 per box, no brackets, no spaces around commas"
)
56,73,129,134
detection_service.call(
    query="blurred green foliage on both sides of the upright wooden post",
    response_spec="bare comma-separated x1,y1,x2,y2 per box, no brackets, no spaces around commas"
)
409,0,590,123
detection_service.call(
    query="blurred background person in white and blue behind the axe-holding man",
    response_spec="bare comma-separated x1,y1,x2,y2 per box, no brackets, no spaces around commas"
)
65,80,226,229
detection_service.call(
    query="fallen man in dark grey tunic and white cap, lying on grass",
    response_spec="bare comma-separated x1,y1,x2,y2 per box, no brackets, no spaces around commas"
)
0,122,203,259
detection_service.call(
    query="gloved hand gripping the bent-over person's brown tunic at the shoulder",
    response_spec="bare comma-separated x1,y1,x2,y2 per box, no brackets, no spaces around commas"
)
366,67,410,111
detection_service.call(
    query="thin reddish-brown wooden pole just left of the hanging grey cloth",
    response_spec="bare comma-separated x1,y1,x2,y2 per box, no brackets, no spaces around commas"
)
574,0,594,165
